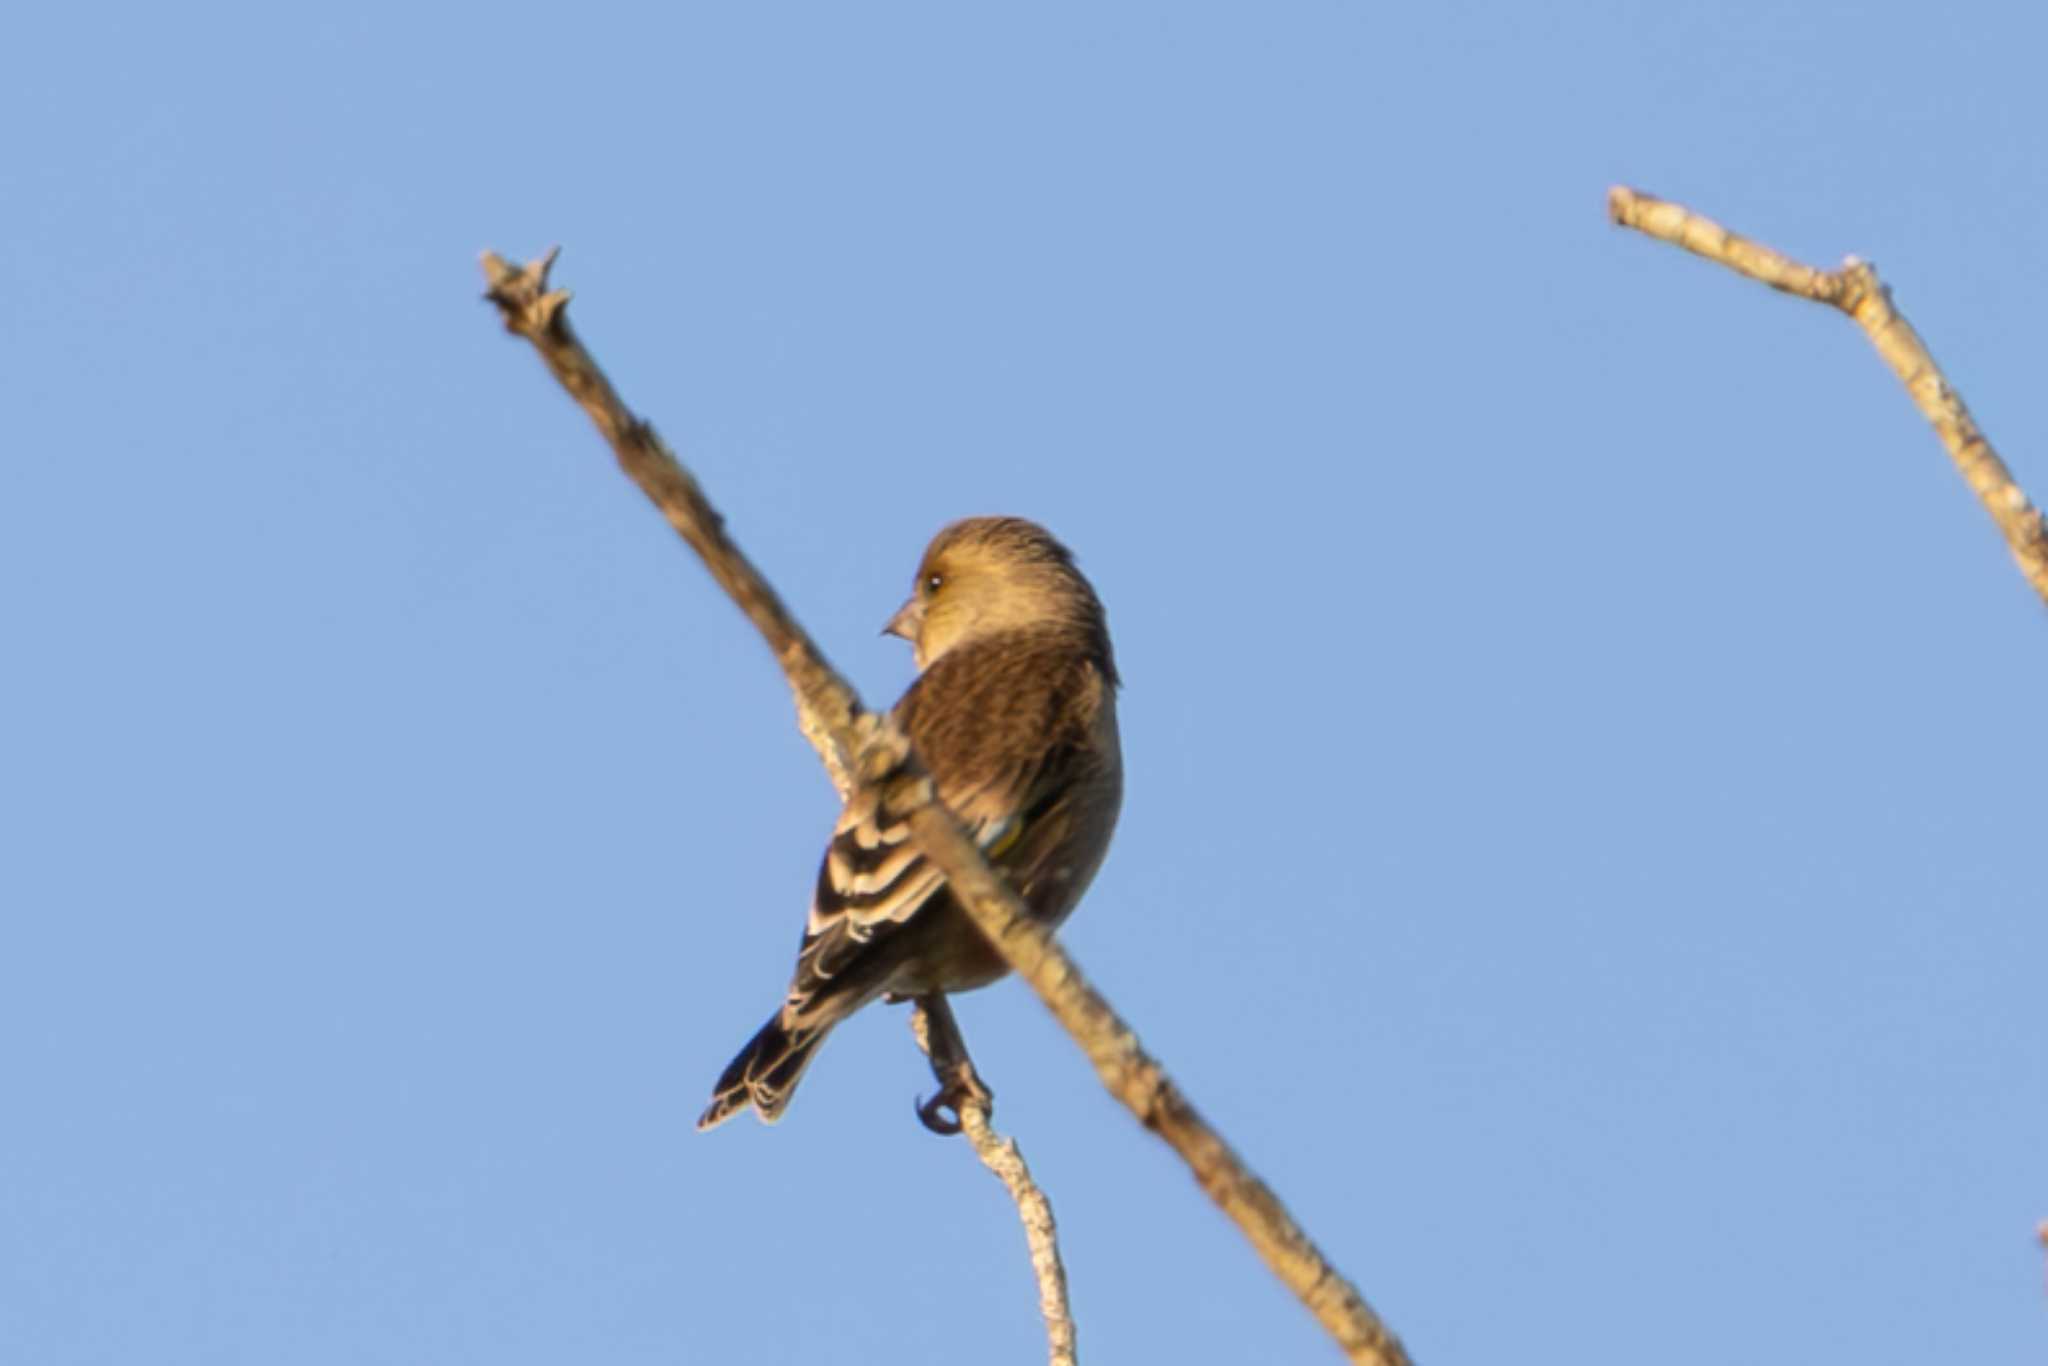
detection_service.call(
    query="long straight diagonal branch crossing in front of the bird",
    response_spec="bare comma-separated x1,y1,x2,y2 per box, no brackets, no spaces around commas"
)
483,252,1407,1366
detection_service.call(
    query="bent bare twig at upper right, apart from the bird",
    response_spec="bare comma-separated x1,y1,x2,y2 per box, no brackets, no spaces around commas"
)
1608,186,2048,602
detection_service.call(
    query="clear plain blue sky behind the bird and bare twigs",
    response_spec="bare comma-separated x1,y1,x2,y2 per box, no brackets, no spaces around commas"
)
0,2,2048,1366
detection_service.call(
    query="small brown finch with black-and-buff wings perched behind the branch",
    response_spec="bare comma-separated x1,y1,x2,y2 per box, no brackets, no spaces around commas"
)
696,516,1122,1130
